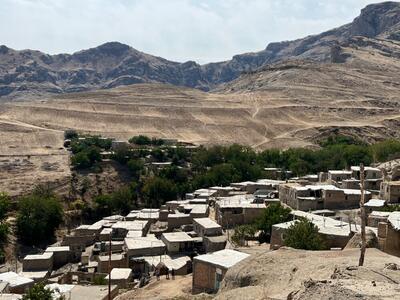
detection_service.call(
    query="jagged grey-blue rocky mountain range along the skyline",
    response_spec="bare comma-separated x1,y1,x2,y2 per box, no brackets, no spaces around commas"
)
0,2,400,98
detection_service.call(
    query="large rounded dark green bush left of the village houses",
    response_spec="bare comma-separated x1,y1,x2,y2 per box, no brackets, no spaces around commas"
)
16,193,63,245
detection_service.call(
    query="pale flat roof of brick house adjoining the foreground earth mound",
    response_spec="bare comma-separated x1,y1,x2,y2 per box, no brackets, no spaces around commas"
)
194,249,250,269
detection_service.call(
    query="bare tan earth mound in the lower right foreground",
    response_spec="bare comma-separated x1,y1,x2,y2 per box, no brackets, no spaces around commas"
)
215,248,400,300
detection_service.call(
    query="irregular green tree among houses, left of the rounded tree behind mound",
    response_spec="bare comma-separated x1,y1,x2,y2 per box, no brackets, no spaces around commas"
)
256,203,291,241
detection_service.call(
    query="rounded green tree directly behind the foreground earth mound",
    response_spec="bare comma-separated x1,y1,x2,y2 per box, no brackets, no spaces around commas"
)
283,218,327,250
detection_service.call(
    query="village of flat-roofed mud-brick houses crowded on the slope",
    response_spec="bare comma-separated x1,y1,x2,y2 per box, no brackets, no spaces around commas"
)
0,155,400,299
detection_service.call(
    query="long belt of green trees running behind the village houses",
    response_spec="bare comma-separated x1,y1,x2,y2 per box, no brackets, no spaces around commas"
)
68,132,400,220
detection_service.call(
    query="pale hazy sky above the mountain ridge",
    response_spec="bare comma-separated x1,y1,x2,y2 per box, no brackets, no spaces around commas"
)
0,0,376,63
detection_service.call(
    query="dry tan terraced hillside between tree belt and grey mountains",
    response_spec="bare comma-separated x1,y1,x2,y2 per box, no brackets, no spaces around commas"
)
0,2,400,193
